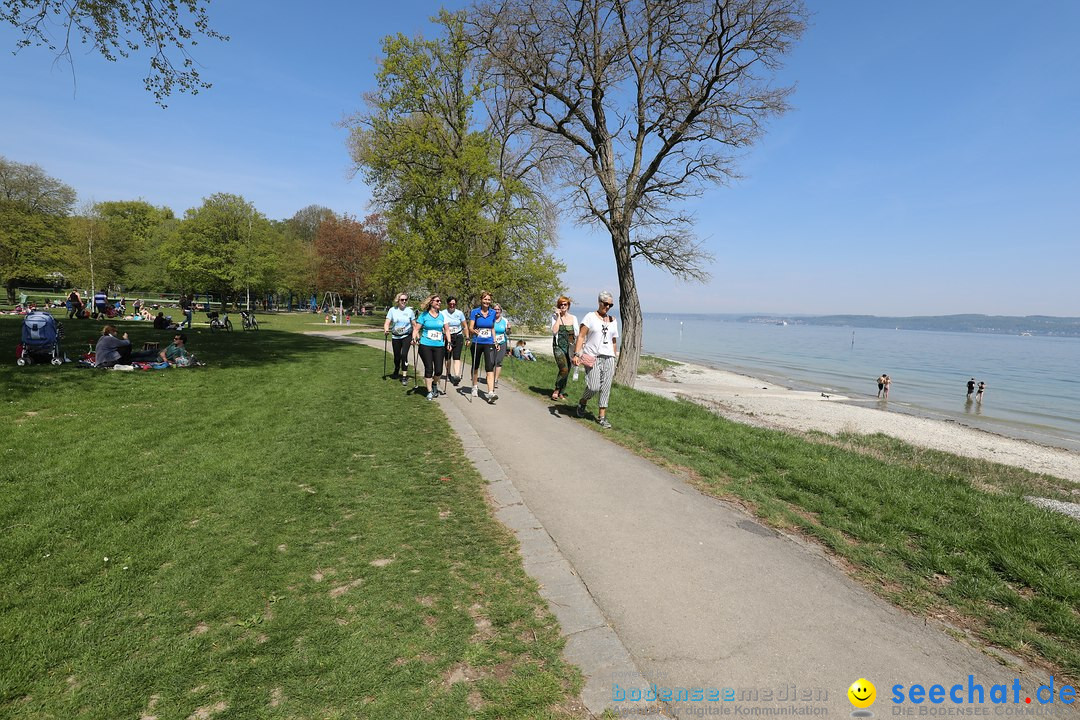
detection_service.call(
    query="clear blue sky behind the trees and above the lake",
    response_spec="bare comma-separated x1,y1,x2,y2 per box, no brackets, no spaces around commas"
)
0,0,1080,315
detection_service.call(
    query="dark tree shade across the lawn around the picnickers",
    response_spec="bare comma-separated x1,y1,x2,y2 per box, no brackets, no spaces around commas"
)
0,315,367,396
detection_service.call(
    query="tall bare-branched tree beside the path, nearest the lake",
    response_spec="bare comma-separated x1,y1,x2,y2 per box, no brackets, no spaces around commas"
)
469,0,806,385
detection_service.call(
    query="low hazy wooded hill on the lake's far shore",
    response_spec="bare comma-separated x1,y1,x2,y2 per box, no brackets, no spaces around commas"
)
742,315,1080,338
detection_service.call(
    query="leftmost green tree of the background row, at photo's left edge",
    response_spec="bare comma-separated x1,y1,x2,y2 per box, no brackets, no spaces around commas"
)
0,155,76,302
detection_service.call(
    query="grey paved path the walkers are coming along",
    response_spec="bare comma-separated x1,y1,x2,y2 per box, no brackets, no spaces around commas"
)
313,334,1077,717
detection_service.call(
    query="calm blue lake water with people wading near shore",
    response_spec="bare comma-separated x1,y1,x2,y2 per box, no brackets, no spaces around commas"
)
644,313,1080,451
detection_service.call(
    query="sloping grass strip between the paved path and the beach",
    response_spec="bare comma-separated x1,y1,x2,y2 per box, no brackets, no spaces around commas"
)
503,353,1080,679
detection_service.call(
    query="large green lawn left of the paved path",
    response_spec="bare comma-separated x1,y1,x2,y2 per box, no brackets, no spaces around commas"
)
0,315,585,720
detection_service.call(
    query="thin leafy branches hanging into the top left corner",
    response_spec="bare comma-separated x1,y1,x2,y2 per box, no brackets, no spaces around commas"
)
0,0,229,107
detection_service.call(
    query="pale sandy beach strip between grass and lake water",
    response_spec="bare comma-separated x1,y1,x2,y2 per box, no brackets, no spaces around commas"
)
637,364,1080,483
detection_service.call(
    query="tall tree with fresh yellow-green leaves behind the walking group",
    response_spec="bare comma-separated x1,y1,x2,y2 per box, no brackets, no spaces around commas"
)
349,12,563,320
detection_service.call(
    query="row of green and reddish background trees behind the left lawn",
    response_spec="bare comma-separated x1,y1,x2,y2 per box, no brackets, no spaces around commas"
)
0,157,387,304
